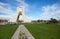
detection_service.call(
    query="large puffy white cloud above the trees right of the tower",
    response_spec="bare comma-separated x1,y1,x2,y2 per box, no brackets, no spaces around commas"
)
40,4,60,19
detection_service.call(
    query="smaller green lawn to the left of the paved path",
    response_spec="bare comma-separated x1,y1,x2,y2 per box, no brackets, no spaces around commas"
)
0,25,18,39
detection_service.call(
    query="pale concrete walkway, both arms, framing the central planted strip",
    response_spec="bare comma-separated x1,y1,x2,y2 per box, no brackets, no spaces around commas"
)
12,25,35,39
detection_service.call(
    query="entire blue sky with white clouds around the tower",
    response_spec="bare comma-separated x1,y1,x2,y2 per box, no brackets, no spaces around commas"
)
0,0,60,20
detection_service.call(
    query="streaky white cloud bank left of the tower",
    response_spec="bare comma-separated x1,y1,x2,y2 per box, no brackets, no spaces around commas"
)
0,2,15,19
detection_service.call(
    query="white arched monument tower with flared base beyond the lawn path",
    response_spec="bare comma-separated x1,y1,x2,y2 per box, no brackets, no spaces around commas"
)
9,7,31,23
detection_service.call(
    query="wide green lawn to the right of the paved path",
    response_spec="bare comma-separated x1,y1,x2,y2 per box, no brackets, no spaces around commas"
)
25,23,60,39
